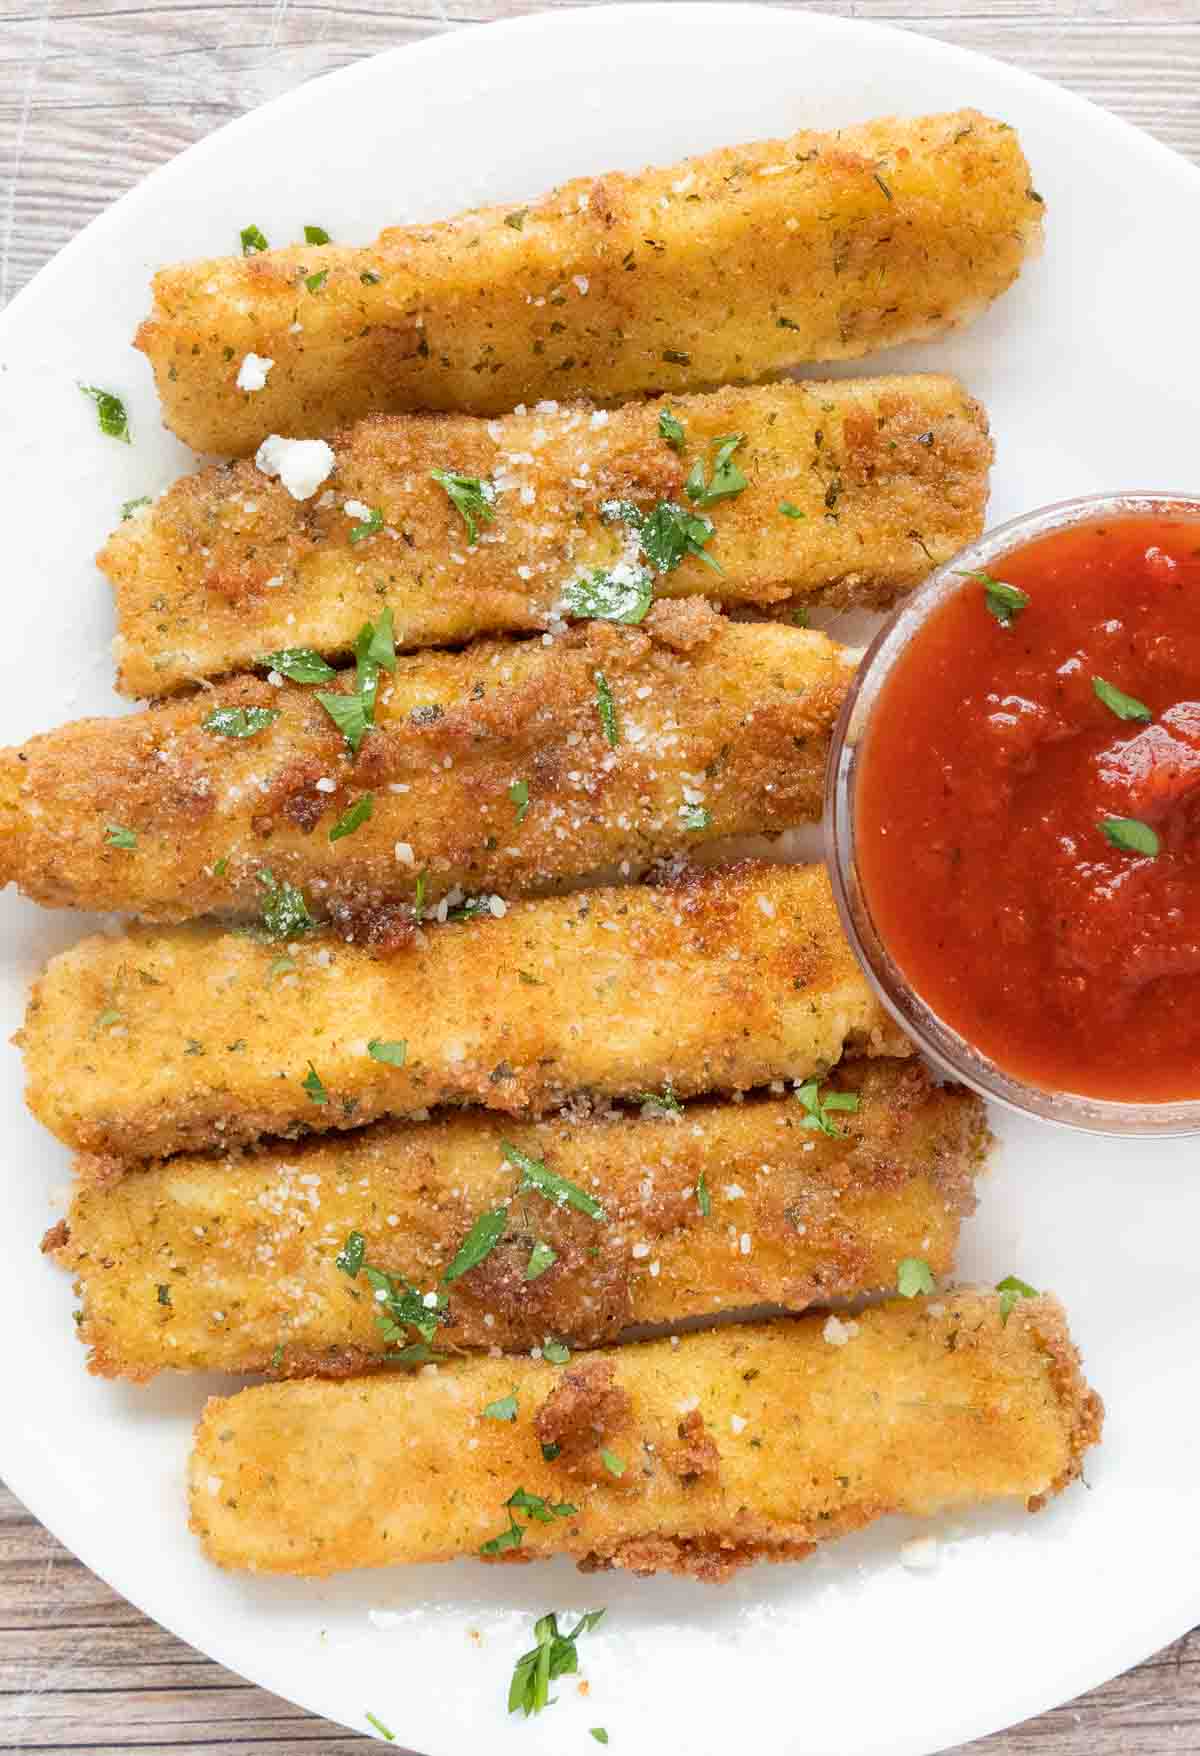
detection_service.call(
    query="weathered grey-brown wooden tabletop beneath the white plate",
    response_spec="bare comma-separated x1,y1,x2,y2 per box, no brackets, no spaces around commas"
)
0,0,1200,1756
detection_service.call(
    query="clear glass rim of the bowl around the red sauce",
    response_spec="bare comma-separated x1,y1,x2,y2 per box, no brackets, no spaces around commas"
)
826,493,1200,1136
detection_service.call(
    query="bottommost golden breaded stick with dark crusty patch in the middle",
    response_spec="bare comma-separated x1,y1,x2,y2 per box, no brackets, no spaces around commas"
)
190,1292,1103,1579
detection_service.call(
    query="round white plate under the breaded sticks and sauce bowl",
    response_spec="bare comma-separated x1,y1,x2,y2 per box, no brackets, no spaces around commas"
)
0,5,1200,1756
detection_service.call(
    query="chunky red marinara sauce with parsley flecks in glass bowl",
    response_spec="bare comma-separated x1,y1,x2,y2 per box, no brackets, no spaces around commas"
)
854,516,1200,1103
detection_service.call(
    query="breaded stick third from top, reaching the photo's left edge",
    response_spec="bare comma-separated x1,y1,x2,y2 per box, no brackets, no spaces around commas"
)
0,601,852,931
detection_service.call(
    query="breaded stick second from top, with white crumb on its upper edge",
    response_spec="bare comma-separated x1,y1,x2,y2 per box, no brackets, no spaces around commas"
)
98,374,991,695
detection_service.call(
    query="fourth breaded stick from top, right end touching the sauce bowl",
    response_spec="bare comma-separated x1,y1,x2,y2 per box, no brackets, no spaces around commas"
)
19,860,910,1159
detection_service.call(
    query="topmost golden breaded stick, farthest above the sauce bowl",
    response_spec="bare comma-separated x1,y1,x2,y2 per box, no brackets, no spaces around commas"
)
137,111,1042,455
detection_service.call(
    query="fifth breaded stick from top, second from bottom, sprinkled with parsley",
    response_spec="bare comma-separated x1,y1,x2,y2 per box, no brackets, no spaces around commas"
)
47,1061,989,1378
